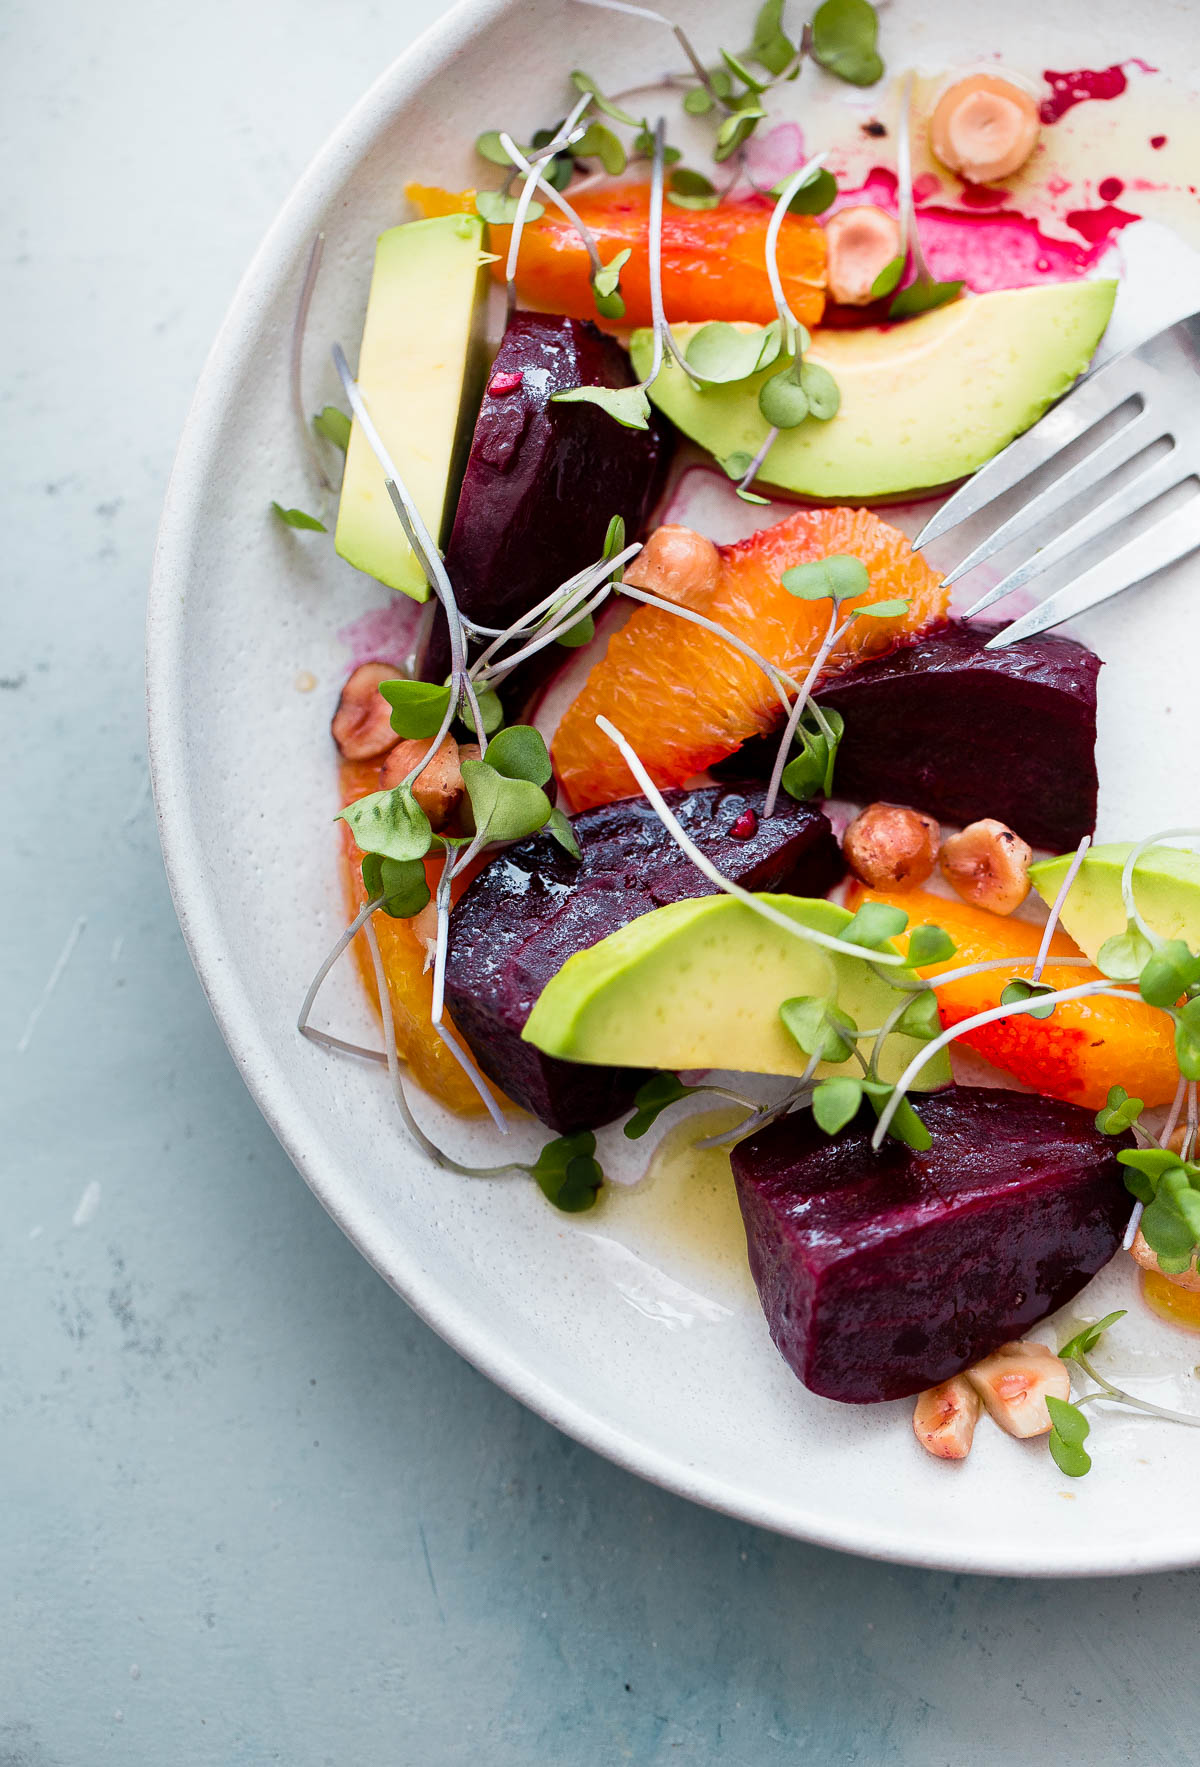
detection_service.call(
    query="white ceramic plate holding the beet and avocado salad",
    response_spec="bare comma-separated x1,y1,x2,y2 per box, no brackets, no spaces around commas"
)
148,0,1200,1574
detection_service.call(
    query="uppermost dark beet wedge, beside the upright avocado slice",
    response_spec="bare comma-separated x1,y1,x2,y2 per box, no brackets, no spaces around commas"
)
421,313,670,703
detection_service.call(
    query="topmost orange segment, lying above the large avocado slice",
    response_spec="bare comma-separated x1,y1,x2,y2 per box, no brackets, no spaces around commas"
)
406,184,825,327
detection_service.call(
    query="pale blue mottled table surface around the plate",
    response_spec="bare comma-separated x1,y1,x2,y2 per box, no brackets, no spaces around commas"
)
0,0,1200,1767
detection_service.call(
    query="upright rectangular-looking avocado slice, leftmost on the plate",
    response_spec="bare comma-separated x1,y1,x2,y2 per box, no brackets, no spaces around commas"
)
334,214,486,601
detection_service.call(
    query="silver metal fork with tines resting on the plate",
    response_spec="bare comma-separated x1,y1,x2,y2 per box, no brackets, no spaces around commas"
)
914,313,1200,650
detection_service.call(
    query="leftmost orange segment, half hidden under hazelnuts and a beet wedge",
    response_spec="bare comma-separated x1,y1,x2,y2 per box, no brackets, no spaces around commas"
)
338,762,498,1117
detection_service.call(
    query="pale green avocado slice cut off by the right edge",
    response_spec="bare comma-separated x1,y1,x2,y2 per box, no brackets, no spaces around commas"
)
1029,841,1200,963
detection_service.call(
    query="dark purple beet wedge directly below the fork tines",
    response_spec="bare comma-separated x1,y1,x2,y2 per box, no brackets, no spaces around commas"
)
714,620,1099,852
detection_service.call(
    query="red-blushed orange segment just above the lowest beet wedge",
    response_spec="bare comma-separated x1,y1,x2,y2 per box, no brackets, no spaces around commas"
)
847,884,1179,1110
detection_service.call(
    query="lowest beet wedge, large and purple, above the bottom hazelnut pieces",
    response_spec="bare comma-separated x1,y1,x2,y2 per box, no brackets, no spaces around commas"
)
733,1087,1133,1405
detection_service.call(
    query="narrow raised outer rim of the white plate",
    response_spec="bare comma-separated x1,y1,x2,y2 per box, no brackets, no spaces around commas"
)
145,0,1200,1578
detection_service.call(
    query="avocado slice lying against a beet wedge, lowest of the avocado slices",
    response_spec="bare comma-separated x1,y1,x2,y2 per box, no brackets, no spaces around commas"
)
521,894,951,1090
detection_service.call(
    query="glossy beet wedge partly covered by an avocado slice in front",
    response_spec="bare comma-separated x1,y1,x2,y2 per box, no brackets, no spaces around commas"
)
445,786,841,1134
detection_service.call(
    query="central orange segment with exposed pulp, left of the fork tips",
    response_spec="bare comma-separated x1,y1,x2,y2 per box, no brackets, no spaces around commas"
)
553,509,949,809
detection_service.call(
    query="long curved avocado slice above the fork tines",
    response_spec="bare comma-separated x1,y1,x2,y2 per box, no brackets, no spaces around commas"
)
631,281,1117,502
